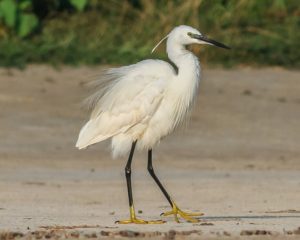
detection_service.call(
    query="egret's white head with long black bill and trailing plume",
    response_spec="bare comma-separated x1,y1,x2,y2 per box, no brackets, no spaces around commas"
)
152,25,230,52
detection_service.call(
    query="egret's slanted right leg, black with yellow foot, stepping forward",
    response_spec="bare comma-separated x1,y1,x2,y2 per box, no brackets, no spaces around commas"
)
148,149,203,223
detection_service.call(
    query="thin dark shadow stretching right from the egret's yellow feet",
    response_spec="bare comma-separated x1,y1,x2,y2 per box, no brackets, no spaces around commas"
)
198,215,300,221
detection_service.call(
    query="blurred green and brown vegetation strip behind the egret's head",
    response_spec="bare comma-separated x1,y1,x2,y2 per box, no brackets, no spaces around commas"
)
0,0,300,68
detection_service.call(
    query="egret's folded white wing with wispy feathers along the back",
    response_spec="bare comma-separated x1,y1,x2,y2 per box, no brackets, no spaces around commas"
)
76,60,174,148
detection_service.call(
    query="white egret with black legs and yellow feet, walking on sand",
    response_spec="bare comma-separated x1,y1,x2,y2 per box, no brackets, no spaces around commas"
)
76,25,229,224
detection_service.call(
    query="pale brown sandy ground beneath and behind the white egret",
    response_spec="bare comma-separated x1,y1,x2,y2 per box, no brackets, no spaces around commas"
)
0,66,300,240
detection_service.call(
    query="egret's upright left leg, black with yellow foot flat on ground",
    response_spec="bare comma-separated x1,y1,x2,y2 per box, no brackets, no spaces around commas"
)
116,141,164,224
